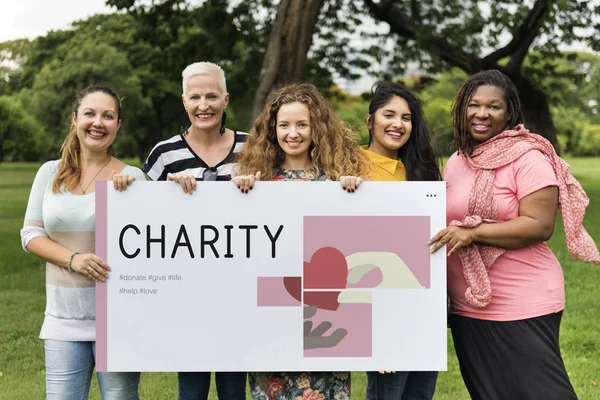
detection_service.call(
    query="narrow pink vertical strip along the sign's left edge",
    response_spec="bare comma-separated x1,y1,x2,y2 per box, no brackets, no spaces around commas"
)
95,181,108,372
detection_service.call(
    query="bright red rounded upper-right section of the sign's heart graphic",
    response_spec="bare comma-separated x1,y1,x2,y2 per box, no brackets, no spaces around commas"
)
304,245,348,289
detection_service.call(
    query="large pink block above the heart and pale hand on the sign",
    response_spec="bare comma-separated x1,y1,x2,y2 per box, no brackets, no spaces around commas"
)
304,216,431,288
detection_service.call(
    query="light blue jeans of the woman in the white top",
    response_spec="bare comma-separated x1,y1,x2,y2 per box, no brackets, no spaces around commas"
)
44,339,140,400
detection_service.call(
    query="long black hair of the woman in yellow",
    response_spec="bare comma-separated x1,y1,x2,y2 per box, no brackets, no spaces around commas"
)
369,82,442,181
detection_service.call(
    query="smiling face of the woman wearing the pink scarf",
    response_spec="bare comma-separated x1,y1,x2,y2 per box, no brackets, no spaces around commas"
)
465,85,510,145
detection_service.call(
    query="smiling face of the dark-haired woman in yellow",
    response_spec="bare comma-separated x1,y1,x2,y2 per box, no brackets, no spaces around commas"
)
367,96,412,159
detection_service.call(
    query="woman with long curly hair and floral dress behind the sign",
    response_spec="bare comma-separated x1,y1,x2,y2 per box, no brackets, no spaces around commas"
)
233,83,369,400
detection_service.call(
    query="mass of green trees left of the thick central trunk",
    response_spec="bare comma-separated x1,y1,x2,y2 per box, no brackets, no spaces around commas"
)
0,0,266,160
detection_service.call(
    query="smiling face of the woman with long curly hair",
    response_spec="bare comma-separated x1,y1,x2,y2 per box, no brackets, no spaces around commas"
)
276,102,312,164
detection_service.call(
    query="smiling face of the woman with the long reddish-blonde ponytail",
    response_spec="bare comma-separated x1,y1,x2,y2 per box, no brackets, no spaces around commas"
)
73,92,121,151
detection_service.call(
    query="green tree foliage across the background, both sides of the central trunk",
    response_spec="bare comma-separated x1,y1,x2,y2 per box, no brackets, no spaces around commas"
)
0,0,600,159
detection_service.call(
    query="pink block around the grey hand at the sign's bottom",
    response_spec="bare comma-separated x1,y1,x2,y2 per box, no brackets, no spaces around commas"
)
304,302,373,357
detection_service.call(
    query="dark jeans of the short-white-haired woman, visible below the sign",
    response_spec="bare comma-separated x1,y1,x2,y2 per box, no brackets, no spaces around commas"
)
177,372,247,400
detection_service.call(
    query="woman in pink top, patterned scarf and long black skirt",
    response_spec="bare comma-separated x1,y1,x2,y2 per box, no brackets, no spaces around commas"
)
431,71,600,400
